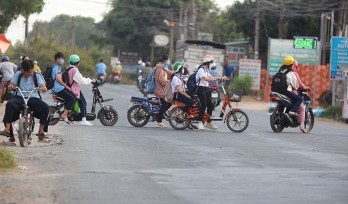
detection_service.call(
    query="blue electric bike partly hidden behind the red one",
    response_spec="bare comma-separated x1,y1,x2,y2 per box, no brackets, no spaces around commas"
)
127,97,161,127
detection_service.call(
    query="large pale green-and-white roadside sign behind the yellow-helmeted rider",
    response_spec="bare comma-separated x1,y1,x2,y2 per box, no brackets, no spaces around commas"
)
267,38,320,75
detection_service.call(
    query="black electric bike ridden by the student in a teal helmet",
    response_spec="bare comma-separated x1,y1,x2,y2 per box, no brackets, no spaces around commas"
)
48,81,118,126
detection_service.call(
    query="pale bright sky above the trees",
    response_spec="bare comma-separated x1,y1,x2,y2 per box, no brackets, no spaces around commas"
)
5,0,236,43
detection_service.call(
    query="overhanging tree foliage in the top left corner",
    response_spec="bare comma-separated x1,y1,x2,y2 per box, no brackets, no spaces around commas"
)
0,0,44,33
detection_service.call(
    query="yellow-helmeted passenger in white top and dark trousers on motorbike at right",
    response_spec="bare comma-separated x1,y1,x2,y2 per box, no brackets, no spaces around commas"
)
279,56,302,118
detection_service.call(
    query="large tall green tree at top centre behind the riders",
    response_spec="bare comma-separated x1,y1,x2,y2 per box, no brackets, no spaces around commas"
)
101,0,213,58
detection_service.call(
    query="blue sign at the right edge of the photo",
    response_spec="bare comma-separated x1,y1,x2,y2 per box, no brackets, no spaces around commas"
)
330,37,348,80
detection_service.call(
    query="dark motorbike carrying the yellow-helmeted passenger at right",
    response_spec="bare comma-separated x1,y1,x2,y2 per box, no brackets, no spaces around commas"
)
270,92,314,133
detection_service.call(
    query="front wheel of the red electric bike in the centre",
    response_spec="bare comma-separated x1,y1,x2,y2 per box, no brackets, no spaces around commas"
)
226,110,249,133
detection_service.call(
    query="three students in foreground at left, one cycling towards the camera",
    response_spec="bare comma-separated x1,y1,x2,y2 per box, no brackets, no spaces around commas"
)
0,52,93,146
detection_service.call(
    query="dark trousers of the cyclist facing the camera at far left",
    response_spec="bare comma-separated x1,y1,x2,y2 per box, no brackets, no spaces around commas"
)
3,96,50,132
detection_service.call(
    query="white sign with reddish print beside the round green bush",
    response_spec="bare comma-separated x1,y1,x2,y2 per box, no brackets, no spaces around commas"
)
239,59,261,91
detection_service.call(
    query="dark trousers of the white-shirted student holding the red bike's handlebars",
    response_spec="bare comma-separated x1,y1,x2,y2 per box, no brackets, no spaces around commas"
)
197,86,214,121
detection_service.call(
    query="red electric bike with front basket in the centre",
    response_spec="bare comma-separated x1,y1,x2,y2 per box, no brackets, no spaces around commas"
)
167,85,249,133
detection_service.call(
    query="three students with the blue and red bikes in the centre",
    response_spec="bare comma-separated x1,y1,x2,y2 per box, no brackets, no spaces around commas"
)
154,55,228,130
